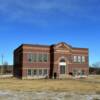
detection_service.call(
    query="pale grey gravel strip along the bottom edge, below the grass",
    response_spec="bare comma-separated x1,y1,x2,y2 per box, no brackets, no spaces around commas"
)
0,91,100,100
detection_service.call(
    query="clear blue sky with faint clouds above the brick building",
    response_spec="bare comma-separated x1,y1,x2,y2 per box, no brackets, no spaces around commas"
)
0,0,100,64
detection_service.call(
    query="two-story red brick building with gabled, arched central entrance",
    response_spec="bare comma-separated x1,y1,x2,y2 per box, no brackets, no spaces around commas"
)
13,42,89,79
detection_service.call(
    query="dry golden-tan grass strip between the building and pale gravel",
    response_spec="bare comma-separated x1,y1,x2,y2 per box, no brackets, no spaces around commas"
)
0,76,100,94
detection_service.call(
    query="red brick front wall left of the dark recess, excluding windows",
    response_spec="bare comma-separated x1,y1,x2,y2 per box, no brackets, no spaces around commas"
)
23,47,50,77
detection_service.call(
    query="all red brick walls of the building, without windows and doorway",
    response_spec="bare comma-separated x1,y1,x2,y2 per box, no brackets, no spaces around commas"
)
14,42,89,77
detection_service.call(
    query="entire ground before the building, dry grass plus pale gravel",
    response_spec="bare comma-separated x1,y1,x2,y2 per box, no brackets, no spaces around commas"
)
0,77,100,100
